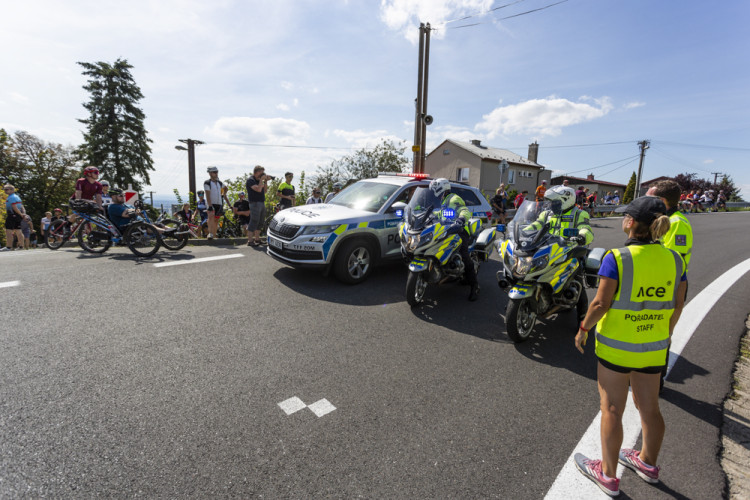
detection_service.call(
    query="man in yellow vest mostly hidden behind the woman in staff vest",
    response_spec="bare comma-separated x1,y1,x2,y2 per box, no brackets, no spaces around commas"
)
646,179,693,388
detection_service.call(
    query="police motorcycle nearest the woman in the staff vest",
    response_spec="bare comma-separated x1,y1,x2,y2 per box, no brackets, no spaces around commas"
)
497,200,605,343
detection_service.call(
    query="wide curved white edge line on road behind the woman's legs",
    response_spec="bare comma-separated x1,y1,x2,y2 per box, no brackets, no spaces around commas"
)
544,259,750,499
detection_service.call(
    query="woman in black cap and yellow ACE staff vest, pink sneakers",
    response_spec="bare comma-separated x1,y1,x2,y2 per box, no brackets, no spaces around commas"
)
575,196,686,496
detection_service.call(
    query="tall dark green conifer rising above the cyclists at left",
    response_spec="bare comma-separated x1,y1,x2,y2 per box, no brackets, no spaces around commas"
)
78,59,154,190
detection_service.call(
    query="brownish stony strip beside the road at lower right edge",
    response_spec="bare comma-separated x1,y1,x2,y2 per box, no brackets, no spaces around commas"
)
721,316,750,499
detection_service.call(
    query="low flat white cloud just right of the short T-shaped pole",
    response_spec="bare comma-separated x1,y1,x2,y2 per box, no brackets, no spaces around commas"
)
205,116,310,145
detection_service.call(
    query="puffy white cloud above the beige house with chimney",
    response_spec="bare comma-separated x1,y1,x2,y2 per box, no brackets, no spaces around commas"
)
475,96,613,139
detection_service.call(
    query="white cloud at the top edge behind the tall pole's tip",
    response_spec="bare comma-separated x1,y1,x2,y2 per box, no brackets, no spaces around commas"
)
380,0,493,44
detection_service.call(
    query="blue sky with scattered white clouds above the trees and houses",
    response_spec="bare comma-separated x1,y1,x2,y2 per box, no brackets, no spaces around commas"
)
0,0,750,199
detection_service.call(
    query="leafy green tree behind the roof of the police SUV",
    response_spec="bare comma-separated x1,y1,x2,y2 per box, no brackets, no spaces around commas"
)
312,139,411,191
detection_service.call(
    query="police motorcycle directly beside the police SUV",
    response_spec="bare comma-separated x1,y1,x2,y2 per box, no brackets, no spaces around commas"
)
398,187,496,307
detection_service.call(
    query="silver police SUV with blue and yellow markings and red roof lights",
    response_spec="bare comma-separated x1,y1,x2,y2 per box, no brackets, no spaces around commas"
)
267,174,492,284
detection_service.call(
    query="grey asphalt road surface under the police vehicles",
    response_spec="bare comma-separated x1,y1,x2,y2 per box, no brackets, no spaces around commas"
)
0,213,750,498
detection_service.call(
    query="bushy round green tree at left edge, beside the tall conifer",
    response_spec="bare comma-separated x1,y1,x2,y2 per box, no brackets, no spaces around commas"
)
0,129,81,245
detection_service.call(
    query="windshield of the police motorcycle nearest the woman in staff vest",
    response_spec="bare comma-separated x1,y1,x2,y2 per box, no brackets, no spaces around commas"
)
507,200,562,253
